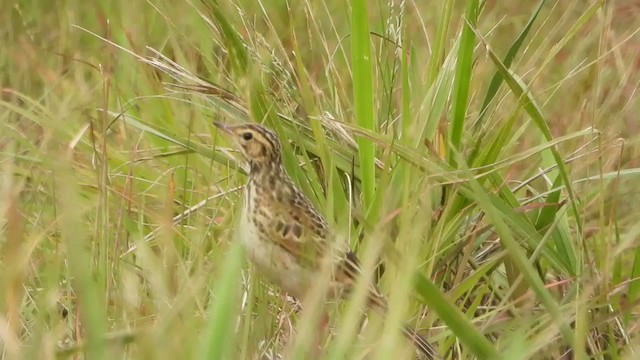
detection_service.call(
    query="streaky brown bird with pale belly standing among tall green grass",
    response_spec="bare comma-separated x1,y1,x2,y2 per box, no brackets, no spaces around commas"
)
213,121,439,359
